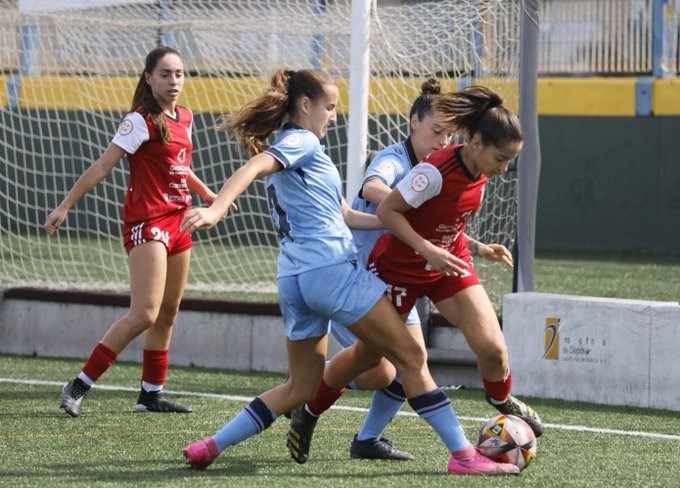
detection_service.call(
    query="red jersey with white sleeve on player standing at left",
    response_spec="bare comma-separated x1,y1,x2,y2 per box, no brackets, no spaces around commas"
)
112,106,193,222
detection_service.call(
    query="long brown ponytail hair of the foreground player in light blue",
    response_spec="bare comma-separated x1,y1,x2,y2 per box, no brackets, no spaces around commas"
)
217,68,333,155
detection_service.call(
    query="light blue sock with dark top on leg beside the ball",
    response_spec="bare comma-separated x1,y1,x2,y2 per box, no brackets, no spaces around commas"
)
408,388,470,452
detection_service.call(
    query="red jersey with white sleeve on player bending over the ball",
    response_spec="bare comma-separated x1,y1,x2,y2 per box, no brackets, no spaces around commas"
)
369,144,487,284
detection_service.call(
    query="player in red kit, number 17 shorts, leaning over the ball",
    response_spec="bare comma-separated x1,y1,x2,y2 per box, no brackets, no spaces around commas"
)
368,86,543,436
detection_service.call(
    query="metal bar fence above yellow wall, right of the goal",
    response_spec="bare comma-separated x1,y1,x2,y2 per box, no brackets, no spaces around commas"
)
538,0,680,76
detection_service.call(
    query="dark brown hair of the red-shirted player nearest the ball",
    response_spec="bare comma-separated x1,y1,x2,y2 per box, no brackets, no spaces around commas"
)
432,85,524,147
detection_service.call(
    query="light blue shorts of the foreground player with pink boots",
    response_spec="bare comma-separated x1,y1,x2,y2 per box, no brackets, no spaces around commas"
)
278,261,387,341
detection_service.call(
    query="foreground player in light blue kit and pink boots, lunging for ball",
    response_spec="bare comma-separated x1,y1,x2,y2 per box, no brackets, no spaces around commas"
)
182,68,519,475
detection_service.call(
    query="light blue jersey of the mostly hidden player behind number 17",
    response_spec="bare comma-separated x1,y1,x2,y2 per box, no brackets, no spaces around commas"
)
352,137,418,264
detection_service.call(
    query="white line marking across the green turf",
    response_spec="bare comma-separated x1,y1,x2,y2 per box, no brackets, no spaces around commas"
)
5,378,680,441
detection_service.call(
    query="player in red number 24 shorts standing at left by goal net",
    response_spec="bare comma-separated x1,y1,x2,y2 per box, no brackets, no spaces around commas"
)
44,46,215,417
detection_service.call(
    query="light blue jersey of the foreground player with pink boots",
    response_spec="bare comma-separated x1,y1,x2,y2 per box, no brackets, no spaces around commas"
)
265,124,358,277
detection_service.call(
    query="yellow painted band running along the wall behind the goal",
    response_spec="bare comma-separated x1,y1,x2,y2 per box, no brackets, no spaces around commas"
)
7,76,680,117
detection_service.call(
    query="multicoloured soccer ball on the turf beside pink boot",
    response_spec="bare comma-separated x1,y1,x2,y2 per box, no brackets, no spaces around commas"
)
477,415,538,469
